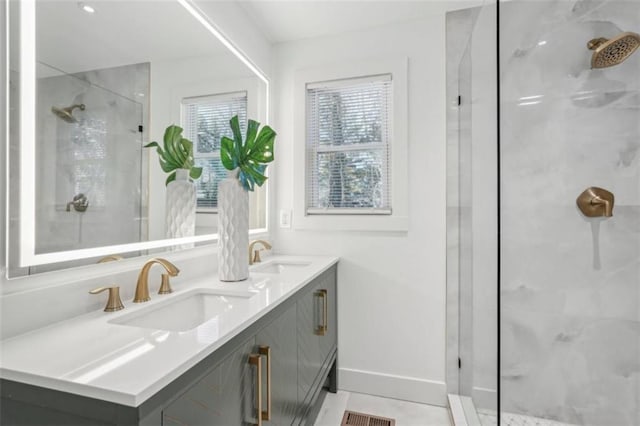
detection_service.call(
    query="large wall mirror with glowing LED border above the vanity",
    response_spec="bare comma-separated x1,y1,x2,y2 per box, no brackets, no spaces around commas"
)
7,0,268,277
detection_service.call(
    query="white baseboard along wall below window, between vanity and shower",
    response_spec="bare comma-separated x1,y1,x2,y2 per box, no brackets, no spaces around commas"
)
338,368,448,407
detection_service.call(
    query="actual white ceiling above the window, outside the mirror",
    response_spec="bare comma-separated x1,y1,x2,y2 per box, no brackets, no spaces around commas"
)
238,0,483,44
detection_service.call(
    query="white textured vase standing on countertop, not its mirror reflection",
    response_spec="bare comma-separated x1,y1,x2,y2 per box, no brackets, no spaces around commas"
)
218,170,249,281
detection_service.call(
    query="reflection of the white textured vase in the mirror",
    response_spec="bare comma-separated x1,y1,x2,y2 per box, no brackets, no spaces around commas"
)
165,169,196,238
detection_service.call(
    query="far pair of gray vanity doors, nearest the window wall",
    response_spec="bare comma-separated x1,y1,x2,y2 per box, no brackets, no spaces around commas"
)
297,268,337,411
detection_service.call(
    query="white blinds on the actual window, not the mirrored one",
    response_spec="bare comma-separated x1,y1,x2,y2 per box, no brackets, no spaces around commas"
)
306,74,392,214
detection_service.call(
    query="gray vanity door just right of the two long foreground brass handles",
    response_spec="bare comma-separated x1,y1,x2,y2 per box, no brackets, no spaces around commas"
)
256,305,298,426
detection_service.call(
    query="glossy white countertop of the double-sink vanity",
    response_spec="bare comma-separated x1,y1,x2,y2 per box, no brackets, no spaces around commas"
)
0,255,338,407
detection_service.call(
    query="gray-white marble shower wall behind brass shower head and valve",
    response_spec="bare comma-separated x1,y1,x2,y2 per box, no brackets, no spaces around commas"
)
500,0,640,426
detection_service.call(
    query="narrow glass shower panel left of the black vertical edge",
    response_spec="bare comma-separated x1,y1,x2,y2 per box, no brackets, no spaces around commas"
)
447,1,498,424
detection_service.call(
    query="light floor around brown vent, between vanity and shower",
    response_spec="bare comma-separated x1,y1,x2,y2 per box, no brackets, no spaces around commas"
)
315,391,452,426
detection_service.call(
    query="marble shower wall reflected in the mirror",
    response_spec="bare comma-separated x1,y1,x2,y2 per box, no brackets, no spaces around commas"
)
32,64,149,264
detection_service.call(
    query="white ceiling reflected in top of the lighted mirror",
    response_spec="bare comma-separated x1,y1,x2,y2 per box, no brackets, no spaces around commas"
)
36,0,235,73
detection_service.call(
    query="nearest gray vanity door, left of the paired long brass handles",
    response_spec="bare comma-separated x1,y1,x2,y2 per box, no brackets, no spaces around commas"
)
162,338,257,426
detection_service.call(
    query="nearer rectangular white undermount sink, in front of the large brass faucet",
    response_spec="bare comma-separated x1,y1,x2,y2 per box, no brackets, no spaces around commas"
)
109,289,254,331
